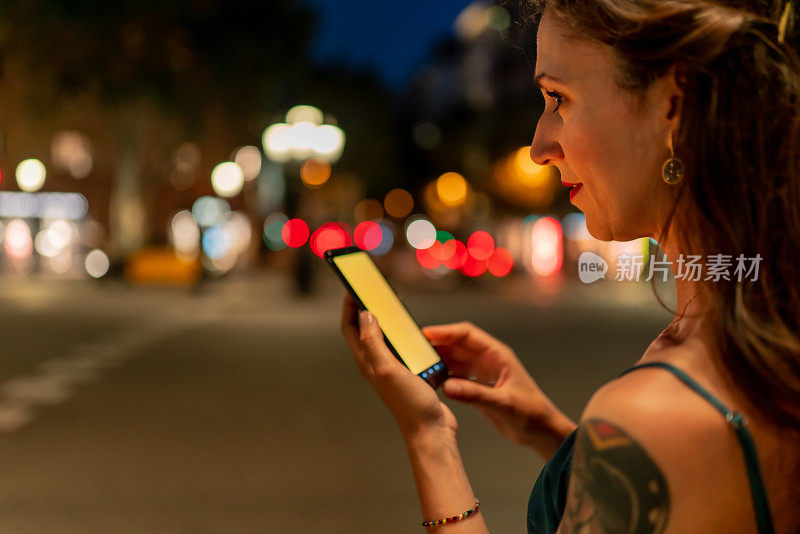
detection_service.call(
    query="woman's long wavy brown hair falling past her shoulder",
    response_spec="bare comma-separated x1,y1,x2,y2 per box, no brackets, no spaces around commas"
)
527,0,800,431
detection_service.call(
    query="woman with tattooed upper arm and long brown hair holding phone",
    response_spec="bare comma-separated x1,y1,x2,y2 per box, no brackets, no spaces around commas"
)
342,0,800,534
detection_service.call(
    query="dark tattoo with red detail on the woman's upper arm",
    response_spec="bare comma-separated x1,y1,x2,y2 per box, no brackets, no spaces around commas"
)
559,419,669,534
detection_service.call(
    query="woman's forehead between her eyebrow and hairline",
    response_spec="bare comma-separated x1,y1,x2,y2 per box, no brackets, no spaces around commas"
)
536,11,616,89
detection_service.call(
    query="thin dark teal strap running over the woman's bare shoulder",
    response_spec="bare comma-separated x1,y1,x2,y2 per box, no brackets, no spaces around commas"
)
619,362,774,534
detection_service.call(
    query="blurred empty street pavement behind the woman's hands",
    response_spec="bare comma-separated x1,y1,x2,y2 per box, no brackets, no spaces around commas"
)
0,273,670,533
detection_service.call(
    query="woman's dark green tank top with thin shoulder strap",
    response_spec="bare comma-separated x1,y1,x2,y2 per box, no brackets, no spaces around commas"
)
528,362,774,534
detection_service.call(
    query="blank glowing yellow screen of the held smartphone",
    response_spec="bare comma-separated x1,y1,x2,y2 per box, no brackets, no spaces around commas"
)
333,252,441,374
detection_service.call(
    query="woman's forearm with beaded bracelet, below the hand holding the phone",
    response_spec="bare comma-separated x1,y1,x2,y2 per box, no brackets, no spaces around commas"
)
406,433,489,534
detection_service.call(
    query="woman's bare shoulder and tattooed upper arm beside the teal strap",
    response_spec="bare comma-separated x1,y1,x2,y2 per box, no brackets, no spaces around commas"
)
559,369,748,534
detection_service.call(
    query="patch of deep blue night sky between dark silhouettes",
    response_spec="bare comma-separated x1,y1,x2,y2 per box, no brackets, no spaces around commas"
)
306,0,471,88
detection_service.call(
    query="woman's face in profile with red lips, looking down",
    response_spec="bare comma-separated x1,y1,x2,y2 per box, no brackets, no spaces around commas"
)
531,12,680,241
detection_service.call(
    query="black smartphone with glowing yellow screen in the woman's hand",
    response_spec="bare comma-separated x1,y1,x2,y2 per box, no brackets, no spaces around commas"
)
325,247,451,389
